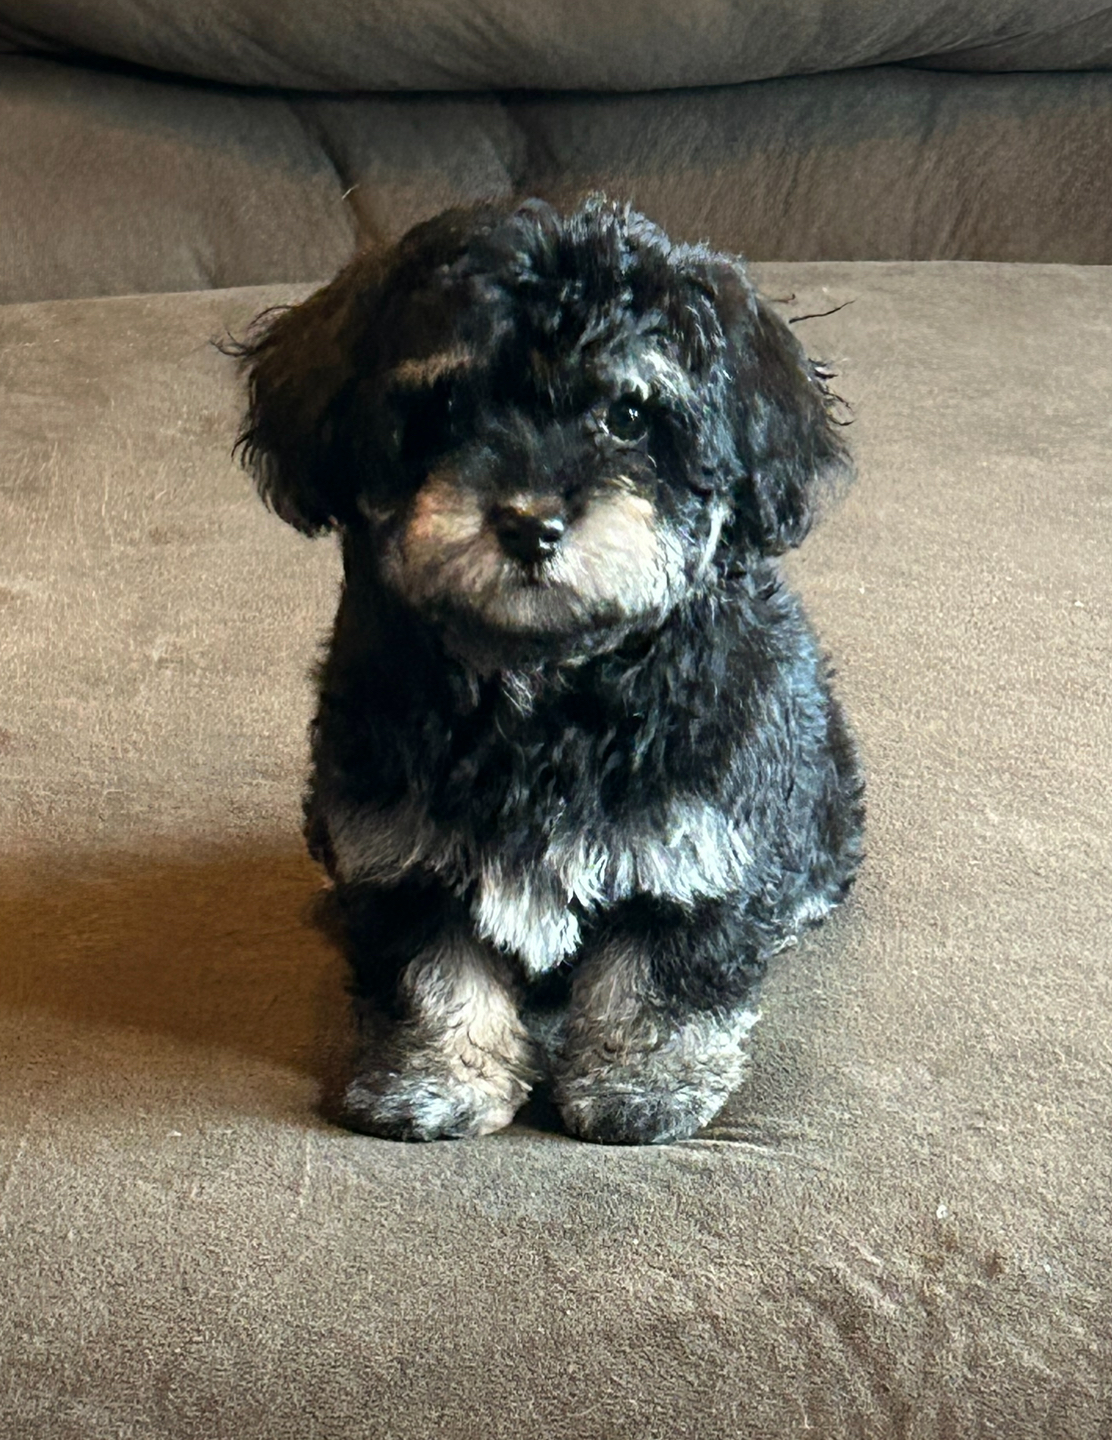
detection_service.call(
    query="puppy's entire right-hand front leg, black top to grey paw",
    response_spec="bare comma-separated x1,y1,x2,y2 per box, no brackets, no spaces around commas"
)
555,906,762,1145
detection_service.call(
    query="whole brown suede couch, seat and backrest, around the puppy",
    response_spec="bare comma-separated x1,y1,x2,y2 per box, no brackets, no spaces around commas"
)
0,0,1112,1440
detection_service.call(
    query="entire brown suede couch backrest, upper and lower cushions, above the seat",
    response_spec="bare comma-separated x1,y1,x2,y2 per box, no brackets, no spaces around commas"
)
0,0,1112,301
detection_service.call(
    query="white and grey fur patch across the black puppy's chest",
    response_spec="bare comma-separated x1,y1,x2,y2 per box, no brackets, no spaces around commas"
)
326,798,752,975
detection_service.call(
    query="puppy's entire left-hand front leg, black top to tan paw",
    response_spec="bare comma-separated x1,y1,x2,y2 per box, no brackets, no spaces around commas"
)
338,894,536,1140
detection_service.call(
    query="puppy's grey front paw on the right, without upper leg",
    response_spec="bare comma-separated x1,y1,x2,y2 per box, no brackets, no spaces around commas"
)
555,1011,756,1145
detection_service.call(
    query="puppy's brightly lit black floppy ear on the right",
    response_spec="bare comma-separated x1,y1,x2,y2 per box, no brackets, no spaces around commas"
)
703,258,851,554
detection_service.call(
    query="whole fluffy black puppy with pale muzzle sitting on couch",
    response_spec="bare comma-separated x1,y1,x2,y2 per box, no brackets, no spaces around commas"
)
230,197,863,1143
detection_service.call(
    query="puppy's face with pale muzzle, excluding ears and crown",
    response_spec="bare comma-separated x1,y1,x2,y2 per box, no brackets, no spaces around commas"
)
360,318,725,644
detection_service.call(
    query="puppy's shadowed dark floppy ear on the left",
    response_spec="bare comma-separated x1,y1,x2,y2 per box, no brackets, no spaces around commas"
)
223,255,382,534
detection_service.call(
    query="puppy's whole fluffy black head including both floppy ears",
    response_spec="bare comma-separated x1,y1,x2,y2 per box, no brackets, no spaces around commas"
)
230,199,844,654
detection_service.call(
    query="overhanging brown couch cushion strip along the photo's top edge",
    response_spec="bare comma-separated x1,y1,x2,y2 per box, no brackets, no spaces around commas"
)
0,0,1112,91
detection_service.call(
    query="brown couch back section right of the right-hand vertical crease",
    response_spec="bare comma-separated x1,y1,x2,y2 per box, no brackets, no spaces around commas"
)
510,66,1112,264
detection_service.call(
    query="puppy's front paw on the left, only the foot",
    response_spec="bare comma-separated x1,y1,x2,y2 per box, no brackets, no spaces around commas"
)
337,1066,529,1140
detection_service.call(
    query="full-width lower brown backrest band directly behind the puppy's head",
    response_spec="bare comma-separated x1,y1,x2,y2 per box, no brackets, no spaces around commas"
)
0,56,1112,301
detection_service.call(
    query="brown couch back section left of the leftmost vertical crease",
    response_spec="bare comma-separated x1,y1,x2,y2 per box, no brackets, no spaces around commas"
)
0,56,354,300
